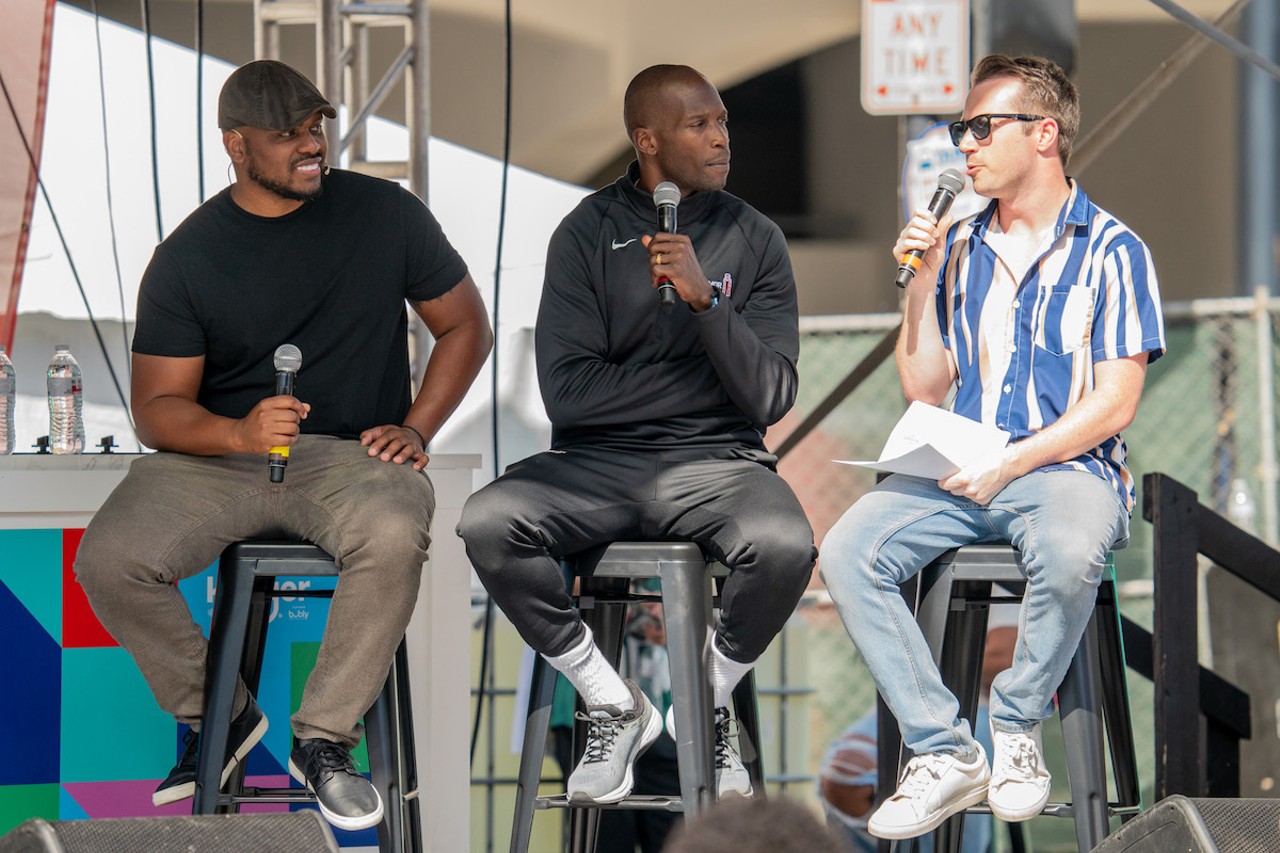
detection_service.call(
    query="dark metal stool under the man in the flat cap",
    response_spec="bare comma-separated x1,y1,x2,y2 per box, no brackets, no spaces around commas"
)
191,540,422,853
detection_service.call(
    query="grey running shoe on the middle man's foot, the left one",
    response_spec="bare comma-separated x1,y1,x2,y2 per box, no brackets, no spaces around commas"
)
568,679,662,803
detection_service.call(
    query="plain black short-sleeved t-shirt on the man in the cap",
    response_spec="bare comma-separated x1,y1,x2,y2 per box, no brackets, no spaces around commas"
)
133,169,467,438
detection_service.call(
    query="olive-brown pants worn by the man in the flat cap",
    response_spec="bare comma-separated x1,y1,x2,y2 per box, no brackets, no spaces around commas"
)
76,435,435,748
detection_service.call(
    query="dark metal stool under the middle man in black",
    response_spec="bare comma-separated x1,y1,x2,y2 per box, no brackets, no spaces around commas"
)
511,542,764,853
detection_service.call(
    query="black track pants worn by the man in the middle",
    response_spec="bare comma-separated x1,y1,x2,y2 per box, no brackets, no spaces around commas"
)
458,448,818,663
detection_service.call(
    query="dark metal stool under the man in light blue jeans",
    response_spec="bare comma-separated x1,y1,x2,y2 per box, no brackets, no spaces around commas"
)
879,546,1142,852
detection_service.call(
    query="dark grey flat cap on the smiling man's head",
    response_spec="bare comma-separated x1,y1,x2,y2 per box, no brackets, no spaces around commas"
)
218,59,338,131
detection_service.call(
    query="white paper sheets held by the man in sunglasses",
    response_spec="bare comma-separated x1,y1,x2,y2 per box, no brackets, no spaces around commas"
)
836,402,1009,480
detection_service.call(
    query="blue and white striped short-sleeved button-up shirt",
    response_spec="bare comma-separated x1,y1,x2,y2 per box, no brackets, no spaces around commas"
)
937,181,1165,511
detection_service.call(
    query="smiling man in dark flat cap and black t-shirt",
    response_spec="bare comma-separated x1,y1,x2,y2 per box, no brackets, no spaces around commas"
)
76,60,492,830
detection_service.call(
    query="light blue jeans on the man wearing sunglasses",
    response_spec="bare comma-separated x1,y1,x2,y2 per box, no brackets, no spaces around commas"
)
820,470,1129,756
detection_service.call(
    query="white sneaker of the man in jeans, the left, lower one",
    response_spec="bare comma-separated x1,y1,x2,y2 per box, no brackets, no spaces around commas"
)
867,744,991,839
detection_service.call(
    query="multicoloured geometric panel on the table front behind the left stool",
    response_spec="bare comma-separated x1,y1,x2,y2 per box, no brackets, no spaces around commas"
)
0,529,378,850
